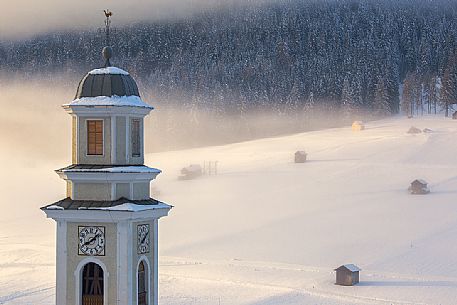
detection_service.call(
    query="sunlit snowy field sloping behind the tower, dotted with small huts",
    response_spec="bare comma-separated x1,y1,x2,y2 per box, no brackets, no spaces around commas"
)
0,117,457,305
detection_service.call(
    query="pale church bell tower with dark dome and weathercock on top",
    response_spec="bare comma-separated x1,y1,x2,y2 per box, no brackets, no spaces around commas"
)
42,11,171,305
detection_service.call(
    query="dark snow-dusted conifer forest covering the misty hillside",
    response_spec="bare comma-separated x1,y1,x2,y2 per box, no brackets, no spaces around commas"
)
0,0,457,120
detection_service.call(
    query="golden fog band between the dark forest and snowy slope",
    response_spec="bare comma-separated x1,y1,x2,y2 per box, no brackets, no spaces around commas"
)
0,75,354,159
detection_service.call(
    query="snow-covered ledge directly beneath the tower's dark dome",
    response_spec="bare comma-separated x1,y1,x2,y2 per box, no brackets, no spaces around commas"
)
64,95,154,109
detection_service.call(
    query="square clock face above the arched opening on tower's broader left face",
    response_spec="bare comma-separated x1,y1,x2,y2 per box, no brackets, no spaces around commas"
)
78,226,105,256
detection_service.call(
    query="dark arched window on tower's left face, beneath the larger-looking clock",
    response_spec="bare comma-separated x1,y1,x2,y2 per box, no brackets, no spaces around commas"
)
81,263,103,305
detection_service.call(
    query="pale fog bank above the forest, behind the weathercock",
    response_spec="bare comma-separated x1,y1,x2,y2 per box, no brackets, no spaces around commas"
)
0,0,253,39
